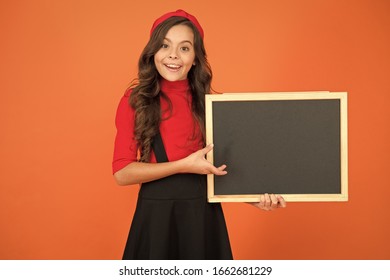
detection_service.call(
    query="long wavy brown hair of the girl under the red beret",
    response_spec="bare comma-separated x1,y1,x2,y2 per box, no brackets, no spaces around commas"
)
129,17,212,162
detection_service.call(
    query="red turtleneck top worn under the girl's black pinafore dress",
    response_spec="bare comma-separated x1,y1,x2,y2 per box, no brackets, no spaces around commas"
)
112,79,202,173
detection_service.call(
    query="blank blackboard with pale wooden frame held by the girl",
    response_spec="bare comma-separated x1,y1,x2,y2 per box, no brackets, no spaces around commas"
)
206,92,348,202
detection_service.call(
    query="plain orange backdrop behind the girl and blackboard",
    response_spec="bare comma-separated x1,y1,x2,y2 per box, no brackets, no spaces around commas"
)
0,0,390,259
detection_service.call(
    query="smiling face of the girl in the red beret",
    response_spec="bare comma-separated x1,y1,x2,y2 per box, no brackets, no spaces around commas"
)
154,25,195,82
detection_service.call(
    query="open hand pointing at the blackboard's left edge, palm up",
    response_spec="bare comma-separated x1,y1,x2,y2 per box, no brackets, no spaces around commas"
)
183,144,227,175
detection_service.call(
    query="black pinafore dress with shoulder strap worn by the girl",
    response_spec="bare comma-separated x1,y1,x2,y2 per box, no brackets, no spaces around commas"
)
123,134,233,260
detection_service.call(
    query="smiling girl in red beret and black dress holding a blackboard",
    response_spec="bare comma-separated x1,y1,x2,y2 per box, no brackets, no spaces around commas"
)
113,10,285,259
